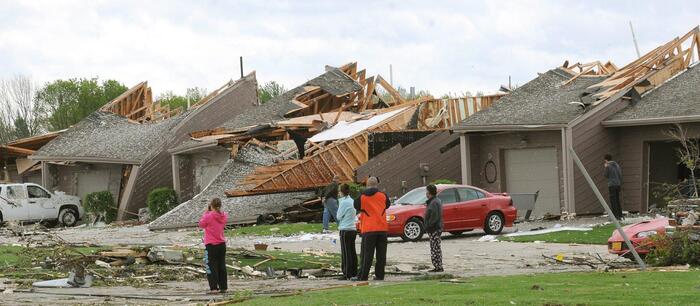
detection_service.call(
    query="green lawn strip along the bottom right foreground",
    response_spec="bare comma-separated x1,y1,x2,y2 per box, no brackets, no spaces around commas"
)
242,270,700,306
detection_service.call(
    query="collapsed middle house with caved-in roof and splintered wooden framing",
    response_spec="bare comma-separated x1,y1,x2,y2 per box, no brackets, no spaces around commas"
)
149,63,508,229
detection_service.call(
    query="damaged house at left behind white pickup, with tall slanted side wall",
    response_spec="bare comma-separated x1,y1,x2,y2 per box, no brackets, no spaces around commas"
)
30,73,257,220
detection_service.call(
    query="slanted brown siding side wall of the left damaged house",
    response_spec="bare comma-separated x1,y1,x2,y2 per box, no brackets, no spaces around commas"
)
125,75,257,218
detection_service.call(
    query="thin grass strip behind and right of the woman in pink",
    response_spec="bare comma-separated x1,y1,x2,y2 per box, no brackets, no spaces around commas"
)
220,222,338,237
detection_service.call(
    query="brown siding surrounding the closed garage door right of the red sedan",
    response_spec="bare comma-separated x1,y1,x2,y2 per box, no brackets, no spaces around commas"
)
469,131,565,207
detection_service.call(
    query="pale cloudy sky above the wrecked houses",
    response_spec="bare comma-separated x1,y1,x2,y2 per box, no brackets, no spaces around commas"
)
0,0,700,95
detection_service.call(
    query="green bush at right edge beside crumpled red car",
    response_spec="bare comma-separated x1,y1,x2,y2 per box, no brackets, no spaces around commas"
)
647,228,700,266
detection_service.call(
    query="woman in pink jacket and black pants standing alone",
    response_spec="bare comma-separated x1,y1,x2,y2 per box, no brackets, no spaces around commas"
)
199,198,228,293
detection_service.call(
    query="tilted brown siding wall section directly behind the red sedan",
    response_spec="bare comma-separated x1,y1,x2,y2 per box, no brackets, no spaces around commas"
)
356,131,462,197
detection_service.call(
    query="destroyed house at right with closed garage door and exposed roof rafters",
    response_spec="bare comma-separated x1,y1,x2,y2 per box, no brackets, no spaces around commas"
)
453,27,700,216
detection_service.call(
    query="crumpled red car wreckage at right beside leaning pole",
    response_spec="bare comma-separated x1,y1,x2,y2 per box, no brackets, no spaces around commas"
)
608,218,669,257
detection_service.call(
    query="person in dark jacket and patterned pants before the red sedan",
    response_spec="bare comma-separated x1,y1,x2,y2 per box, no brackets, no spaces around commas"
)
424,184,444,272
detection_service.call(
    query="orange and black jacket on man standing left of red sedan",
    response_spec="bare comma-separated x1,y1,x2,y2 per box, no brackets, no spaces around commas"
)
355,188,391,234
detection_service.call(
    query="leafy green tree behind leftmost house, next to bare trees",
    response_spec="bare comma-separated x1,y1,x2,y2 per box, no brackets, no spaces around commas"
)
36,78,128,131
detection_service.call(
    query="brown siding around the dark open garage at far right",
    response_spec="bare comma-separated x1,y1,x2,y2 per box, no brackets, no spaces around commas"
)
609,123,700,211
